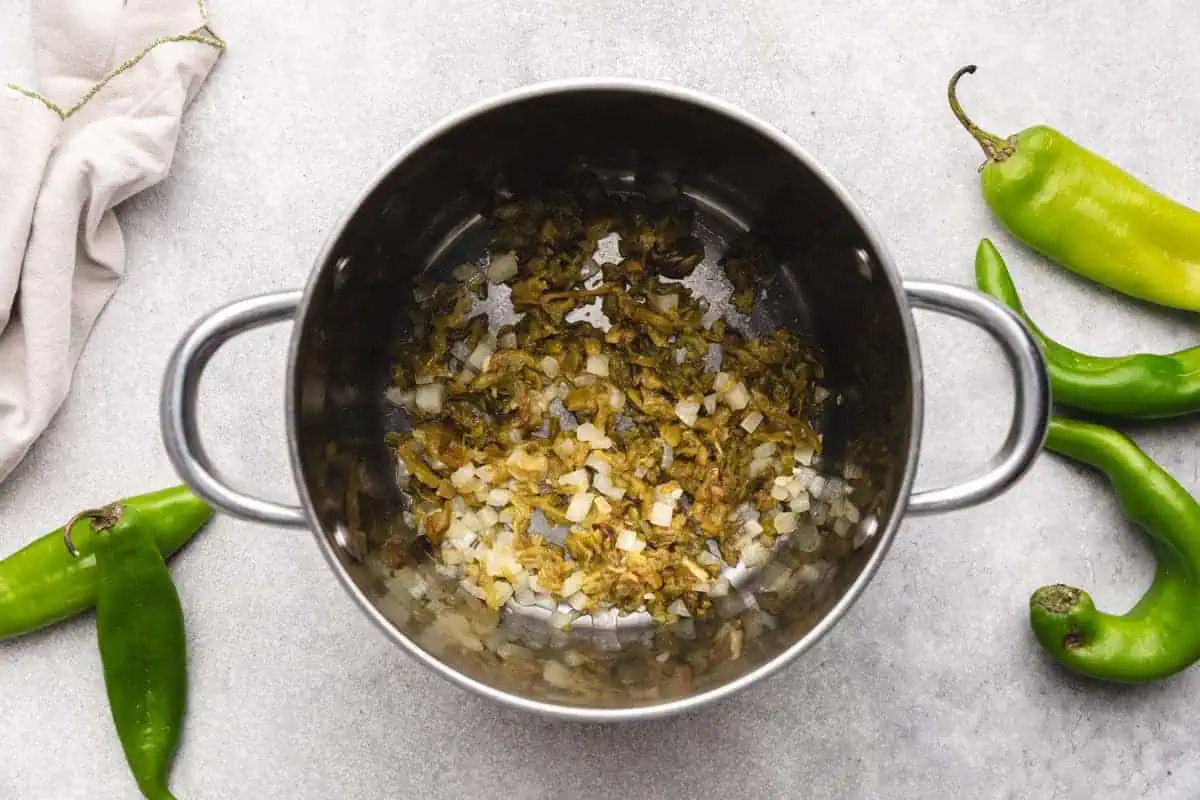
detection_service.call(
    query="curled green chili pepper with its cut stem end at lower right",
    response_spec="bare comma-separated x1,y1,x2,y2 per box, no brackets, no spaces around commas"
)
1030,417,1200,682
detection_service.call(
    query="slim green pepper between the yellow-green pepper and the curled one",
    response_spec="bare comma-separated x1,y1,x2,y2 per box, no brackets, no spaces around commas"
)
976,239,1200,419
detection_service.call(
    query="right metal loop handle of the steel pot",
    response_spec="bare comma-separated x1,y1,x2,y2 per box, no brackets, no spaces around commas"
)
904,281,1051,513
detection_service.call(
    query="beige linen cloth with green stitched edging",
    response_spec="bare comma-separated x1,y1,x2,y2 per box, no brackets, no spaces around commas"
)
0,0,224,481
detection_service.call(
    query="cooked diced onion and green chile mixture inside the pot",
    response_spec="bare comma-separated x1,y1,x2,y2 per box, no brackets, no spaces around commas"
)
379,183,859,626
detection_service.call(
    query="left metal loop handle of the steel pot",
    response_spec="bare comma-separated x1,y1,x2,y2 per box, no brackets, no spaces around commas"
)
158,289,307,527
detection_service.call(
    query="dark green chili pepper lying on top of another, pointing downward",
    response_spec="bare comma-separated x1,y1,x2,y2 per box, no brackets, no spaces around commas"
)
78,504,187,800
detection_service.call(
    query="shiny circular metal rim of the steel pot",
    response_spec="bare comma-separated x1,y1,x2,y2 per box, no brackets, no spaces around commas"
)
284,78,924,722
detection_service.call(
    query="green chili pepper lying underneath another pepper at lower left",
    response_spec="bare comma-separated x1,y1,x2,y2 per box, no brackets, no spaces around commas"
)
0,486,212,640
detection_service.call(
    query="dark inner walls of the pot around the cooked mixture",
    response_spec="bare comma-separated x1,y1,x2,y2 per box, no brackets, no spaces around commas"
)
292,85,919,714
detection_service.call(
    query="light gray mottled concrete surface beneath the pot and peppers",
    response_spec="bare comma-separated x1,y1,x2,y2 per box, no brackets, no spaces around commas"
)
0,0,1200,800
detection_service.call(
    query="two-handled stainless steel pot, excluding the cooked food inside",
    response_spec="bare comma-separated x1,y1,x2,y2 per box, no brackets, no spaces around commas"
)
162,80,1050,721
